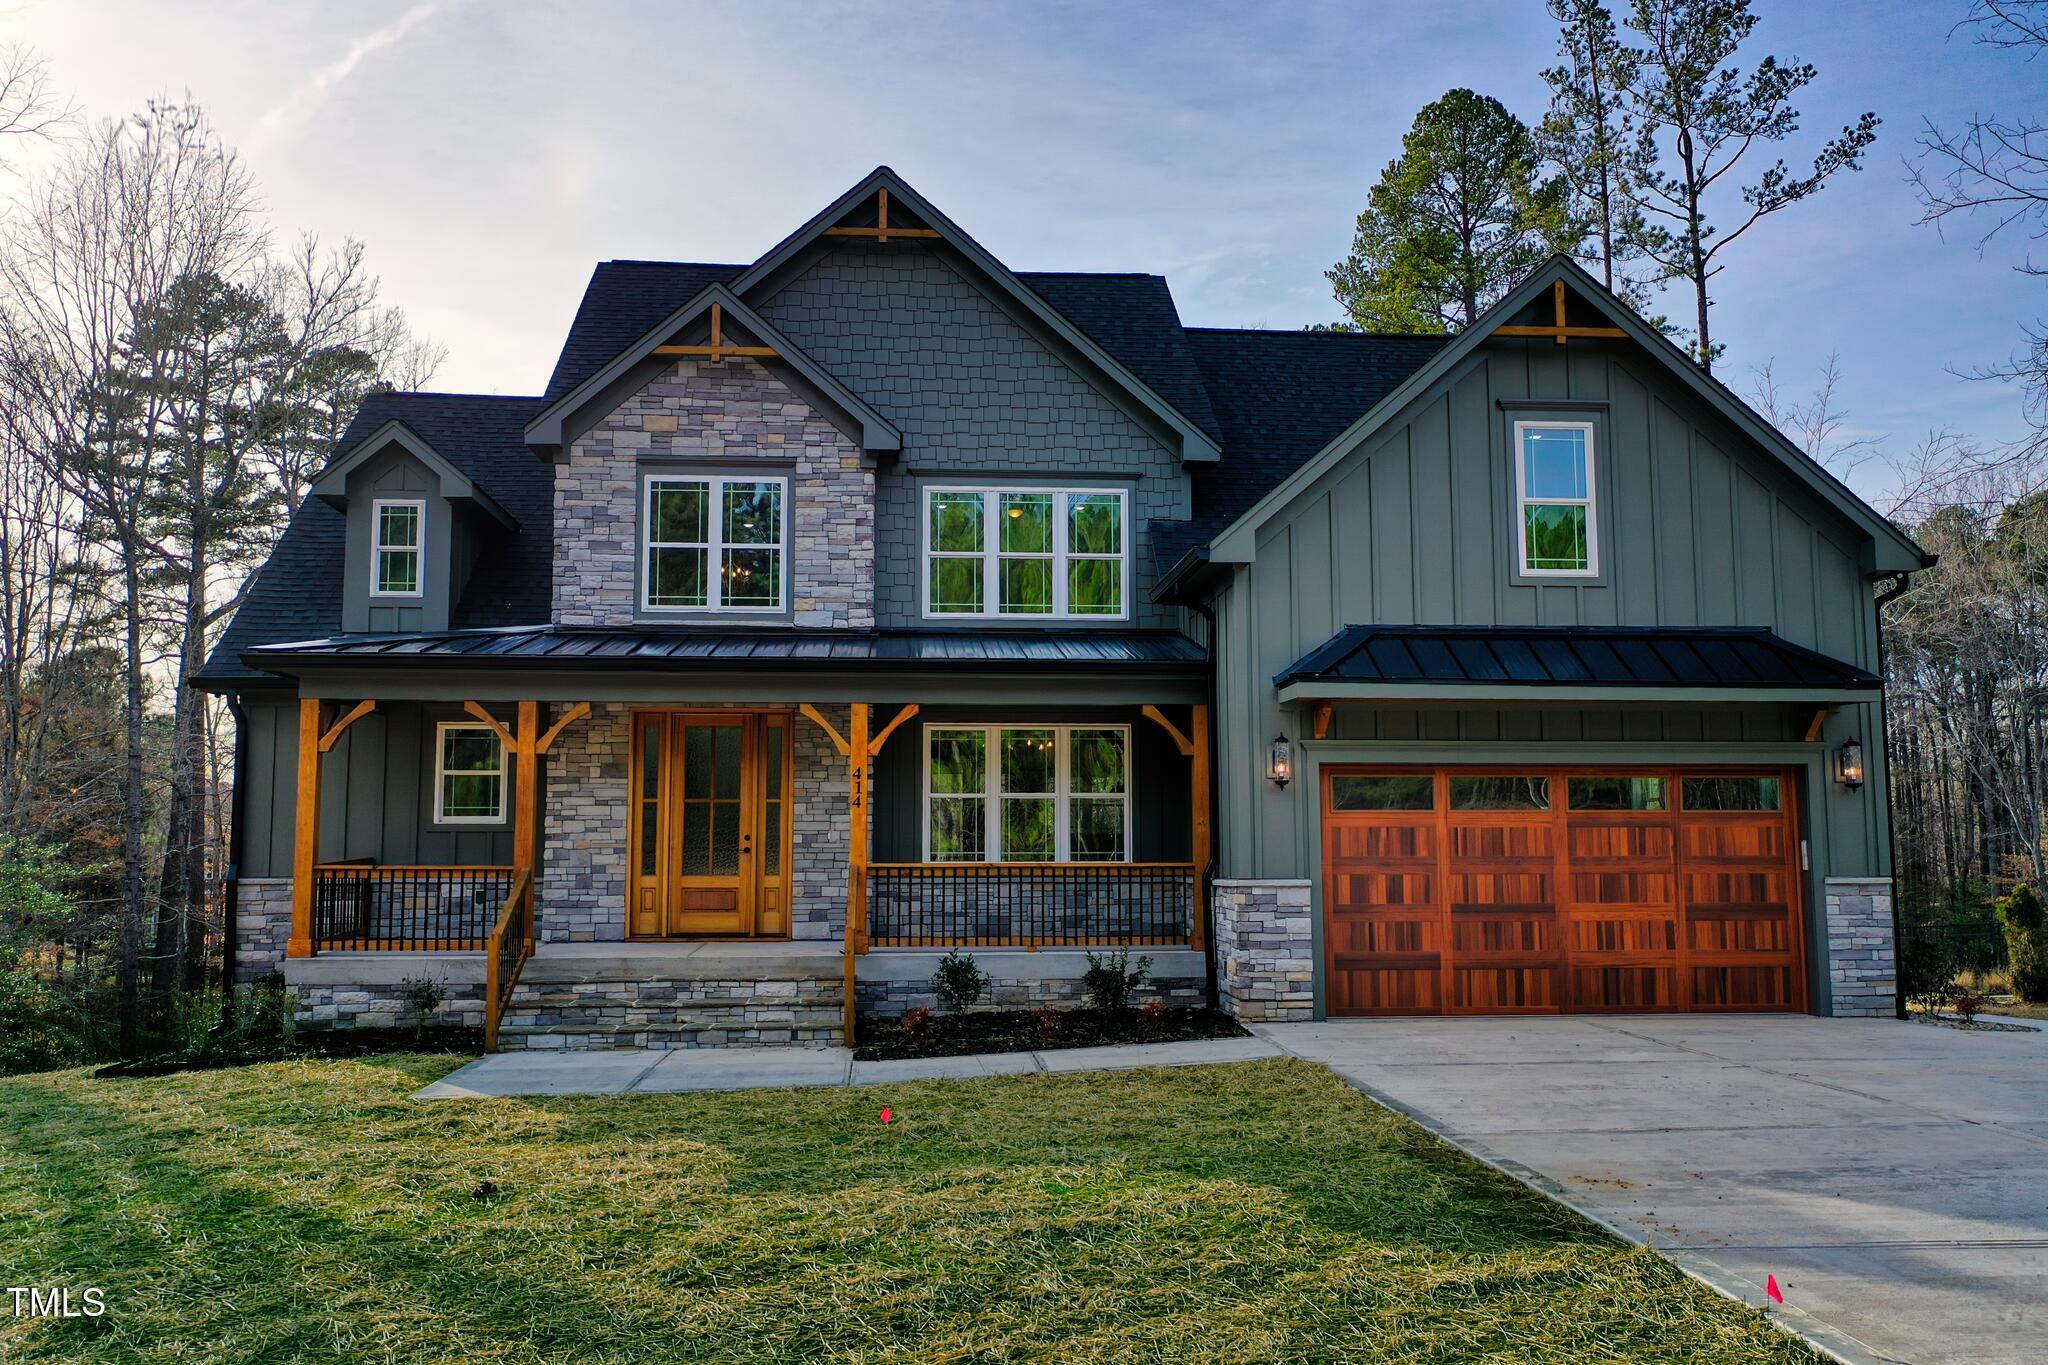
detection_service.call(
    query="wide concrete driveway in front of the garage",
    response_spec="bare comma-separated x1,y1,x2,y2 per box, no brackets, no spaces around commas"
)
1257,1015,2048,1365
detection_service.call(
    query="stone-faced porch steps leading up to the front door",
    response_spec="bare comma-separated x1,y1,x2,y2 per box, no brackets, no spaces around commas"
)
498,941,844,1052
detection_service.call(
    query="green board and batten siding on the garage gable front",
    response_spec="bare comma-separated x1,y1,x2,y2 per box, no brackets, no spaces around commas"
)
1214,338,1890,878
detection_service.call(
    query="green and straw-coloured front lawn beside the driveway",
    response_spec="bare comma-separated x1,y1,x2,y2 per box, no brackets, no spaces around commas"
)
0,1056,1815,1363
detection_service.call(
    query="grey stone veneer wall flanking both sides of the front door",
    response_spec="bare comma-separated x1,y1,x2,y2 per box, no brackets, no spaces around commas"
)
539,702,848,943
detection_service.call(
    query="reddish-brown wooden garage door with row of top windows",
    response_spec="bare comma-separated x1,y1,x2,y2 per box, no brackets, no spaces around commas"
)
1323,767,1806,1015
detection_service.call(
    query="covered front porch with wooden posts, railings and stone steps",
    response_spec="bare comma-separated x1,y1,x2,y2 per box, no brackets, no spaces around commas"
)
264,698,1210,1048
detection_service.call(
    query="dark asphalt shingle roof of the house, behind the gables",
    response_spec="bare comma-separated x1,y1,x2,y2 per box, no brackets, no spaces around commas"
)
201,260,1446,684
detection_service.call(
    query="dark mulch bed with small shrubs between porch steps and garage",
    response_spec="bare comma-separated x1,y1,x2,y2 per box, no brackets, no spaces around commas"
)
854,1005,1249,1062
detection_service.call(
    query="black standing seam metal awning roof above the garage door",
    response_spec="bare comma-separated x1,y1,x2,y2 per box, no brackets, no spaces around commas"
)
1274,626,1882,690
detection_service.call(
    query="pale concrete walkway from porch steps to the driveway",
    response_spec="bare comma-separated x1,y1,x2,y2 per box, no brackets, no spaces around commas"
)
414,1038,1282,1099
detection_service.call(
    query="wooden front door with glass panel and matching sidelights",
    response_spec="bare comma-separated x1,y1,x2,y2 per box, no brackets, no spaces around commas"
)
629,710,791,937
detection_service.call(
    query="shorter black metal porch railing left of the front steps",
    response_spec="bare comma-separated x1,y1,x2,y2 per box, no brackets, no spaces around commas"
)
313,864,512,952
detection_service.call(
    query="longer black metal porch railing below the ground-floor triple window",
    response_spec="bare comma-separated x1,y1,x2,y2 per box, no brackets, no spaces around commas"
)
866,864,1196,948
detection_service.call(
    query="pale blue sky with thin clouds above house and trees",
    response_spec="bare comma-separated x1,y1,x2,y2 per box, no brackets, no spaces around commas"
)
0,0,2048,497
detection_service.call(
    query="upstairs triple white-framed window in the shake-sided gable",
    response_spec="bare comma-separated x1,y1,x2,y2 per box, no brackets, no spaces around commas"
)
920,485,1130,620
